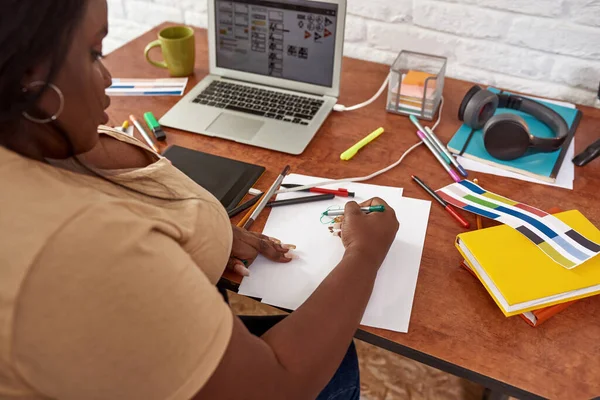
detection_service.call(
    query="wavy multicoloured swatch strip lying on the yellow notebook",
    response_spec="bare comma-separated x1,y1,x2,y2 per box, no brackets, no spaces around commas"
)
437,180,600,269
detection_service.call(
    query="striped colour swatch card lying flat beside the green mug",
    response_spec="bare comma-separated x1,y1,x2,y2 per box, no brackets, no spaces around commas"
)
106,78,188,96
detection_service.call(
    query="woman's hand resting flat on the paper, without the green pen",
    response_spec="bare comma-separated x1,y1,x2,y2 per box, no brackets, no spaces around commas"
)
227,225,296,276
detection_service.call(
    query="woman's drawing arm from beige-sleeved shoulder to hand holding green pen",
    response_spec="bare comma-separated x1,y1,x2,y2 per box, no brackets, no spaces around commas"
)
11,203,398,400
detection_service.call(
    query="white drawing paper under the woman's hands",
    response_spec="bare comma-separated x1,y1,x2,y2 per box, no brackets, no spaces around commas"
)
239,175,431,332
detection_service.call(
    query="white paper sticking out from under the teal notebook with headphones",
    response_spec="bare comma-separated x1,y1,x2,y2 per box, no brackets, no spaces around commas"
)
457,138,575,190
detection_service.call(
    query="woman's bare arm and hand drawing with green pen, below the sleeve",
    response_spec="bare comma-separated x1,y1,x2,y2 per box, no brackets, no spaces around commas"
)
196,201,398,400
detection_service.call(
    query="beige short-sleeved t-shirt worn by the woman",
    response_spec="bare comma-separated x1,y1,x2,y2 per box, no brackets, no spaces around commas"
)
0,128,233,400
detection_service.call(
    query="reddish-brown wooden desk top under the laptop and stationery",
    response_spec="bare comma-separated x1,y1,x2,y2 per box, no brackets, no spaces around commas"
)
105,26,600,399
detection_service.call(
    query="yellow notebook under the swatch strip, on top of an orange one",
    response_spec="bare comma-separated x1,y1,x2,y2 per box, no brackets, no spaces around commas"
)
456,211,600,317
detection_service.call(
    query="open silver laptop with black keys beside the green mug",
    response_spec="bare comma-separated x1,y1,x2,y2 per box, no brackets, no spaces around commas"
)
160,0,346,154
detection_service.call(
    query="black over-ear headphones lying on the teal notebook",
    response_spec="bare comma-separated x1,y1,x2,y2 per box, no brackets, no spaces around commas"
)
458,85,569,160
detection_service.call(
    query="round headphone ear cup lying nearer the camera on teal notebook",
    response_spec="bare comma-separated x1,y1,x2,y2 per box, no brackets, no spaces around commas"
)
483,114,531,161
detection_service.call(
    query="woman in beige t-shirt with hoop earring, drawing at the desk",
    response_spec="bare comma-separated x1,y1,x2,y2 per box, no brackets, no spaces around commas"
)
0,0,398,400
